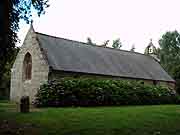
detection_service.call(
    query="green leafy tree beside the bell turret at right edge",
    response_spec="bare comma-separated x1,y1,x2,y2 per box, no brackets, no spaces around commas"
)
159,30,180,92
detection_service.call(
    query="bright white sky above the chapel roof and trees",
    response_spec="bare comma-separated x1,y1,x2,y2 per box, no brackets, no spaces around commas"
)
18,0,180,53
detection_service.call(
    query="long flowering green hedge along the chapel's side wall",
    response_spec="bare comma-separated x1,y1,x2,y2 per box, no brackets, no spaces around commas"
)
34,79,179,107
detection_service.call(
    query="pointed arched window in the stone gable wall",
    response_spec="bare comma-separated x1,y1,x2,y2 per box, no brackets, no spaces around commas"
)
23,53,32,80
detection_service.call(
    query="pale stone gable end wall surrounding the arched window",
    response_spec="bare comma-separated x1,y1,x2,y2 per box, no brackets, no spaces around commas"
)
10,28,49,102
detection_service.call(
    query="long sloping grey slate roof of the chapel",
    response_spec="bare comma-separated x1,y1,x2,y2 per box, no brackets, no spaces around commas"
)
36,32,174,82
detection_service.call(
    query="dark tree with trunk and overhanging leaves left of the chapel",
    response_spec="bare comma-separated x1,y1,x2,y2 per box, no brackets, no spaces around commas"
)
0,0,49,98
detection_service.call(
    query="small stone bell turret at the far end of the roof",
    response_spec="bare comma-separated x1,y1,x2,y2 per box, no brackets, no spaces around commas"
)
144,39,160,62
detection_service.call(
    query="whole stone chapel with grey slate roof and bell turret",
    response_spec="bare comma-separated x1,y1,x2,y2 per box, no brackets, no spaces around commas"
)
10,26,175,102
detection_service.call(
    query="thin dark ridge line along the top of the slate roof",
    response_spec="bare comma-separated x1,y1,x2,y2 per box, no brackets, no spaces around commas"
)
35,32,147,56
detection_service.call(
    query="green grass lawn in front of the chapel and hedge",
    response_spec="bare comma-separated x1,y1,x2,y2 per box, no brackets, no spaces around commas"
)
0,101,180,135
